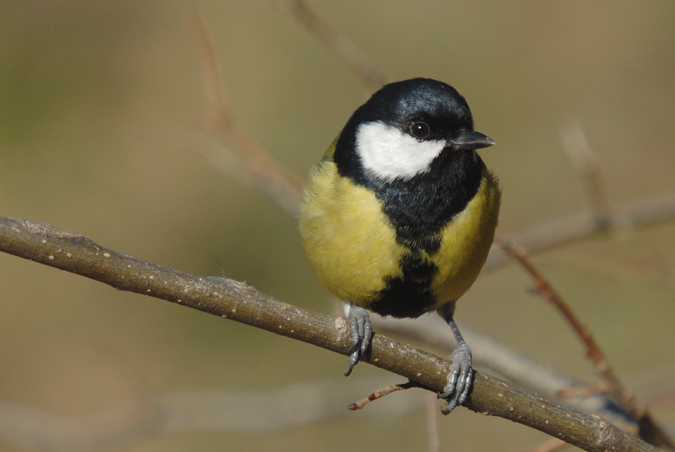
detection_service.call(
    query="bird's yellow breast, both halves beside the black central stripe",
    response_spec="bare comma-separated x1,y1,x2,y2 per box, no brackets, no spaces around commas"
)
300,160,499,309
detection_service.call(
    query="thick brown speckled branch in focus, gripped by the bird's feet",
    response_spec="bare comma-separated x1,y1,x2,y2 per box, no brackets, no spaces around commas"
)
0,217,658,451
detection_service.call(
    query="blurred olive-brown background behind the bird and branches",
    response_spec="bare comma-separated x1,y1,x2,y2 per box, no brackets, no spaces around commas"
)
0,0,675,451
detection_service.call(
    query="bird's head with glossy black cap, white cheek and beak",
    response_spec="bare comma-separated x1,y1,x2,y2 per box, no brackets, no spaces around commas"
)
334,78,494,183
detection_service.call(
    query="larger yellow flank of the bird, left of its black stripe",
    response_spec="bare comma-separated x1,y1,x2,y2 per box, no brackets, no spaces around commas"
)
300,160,405,306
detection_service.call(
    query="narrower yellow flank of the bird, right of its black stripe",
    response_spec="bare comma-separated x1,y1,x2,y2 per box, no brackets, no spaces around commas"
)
432,170,500,307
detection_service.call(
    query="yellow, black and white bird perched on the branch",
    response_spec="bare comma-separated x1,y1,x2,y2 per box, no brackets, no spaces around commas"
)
299,78,501,414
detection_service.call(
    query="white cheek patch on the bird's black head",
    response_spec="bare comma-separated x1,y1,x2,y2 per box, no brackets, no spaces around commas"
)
356,121,446,181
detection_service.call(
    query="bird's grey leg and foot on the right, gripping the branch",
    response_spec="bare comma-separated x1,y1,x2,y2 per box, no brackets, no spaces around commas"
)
438,302,473,414
